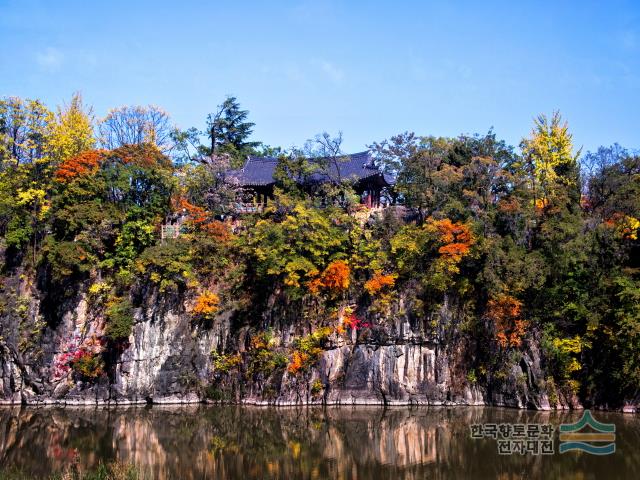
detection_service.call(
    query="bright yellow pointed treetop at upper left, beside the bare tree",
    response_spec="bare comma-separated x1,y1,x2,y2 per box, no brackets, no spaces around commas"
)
48,93,95,164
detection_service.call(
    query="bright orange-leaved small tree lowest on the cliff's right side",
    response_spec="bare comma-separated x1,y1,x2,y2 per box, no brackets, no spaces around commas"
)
487,294,527,348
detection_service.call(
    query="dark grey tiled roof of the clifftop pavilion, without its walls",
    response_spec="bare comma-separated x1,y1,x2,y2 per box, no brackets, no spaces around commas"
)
227,152,393,187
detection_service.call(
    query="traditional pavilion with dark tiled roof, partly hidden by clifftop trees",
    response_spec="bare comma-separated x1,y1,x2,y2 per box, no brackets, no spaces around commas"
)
227,152,394,208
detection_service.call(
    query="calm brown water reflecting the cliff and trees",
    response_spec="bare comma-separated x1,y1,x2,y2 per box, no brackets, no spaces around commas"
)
0,406,640,479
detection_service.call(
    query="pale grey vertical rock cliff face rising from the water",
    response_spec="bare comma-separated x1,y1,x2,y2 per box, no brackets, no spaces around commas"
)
0,274,579,409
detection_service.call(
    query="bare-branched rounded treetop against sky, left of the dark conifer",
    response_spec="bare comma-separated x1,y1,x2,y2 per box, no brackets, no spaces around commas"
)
98,105,174,153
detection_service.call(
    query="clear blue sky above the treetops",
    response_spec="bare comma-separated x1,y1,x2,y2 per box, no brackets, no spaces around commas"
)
0,0,640,152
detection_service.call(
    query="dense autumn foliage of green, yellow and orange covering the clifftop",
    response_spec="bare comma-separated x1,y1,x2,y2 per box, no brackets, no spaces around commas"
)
0,97,640,405
